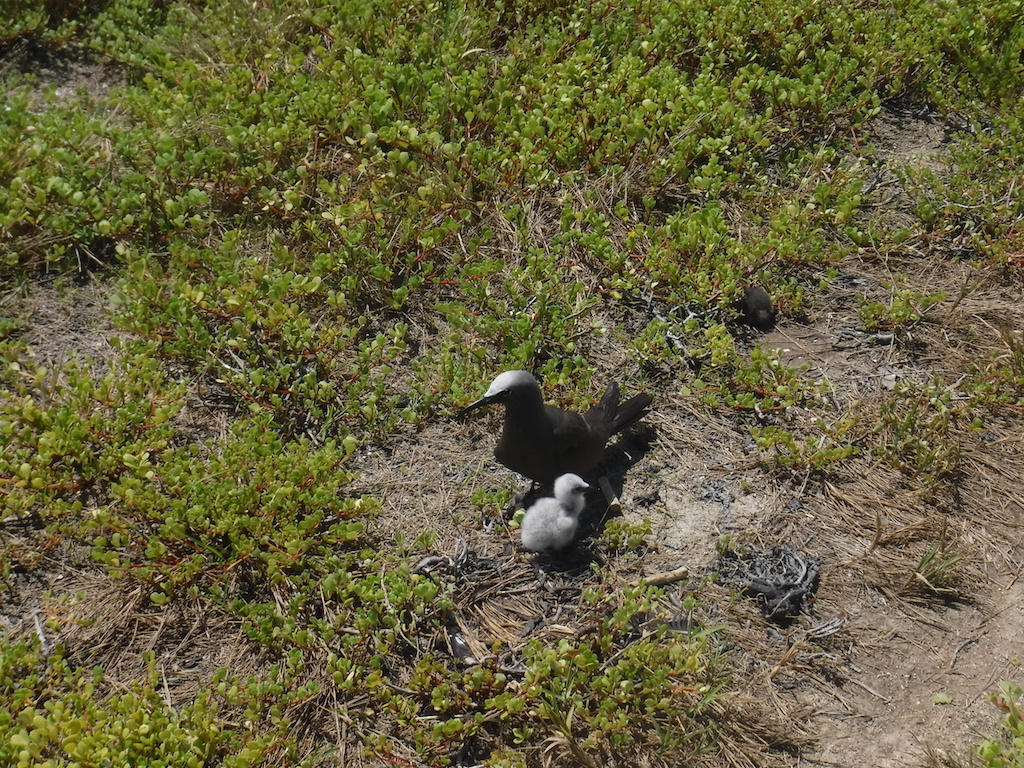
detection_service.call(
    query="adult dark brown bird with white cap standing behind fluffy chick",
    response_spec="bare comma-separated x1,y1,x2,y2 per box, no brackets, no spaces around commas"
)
456,371,651,487
